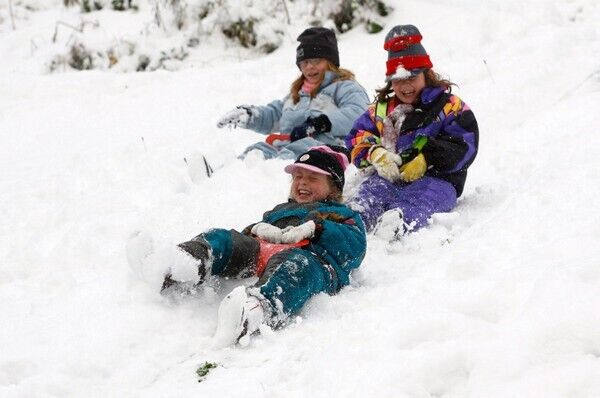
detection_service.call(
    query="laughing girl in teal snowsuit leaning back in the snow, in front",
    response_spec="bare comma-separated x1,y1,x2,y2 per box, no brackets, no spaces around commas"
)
162,146,366,346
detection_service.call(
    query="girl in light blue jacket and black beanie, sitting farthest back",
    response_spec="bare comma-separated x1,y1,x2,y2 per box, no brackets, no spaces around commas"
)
217,27,369,159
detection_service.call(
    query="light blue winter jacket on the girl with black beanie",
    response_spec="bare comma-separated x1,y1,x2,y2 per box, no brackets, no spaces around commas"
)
247,71,369,145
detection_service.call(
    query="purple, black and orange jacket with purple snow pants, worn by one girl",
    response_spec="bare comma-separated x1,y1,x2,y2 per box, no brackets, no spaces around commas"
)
346,87,479,229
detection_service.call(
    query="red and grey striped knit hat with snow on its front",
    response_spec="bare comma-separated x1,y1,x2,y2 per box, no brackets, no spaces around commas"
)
383,25,433,82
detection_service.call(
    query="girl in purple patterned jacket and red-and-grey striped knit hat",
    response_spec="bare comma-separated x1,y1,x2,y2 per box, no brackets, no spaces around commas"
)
346,25,479,237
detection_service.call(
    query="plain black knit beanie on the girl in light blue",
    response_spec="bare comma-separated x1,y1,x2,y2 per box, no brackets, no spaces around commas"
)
296,27,340,66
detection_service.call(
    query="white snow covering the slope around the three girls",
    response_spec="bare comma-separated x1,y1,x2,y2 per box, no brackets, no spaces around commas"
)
0,0,600,397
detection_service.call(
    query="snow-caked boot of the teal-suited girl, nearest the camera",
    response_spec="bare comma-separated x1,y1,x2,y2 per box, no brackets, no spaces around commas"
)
213,286,265,348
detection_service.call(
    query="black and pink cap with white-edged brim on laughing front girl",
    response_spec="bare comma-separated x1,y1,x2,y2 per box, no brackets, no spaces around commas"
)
284,145,350,192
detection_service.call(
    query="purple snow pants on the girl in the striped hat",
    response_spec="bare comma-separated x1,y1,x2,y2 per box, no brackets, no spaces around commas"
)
349,174,456,231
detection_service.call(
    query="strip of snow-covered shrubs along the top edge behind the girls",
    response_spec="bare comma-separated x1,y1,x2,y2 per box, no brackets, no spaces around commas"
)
41,0,391,71
